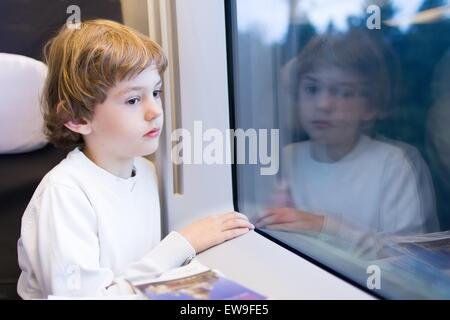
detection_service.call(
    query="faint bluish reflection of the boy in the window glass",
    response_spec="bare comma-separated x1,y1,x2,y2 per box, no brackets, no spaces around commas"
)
257,31,437,242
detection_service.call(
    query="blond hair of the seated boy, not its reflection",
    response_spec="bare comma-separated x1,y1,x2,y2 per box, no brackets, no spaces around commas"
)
43,19,167,149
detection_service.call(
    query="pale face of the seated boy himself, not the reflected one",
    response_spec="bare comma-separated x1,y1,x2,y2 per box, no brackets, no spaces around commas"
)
84,66,163,158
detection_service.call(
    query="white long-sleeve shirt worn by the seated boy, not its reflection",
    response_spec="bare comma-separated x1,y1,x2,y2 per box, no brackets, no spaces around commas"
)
17,149,195,299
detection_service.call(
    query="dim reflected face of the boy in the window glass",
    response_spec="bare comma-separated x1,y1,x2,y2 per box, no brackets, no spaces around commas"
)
298,66,376,145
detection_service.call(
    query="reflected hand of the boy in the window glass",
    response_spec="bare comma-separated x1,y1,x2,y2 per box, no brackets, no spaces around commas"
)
255,208,325,232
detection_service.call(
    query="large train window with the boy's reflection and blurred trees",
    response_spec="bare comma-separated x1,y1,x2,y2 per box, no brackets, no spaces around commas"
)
226,0,450,298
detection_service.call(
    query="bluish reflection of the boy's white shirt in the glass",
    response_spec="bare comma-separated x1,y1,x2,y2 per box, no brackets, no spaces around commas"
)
284,135,439,241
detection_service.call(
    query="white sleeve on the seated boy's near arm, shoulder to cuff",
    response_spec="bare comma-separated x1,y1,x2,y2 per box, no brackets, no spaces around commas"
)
19,185,195,297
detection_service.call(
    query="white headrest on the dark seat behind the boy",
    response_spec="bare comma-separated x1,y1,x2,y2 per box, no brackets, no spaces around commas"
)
0,53,47,153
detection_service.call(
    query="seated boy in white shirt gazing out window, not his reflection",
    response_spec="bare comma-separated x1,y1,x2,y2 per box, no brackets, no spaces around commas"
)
18,20,253,299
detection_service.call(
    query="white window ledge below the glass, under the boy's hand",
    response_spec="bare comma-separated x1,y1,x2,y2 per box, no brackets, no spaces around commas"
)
197,231,374,300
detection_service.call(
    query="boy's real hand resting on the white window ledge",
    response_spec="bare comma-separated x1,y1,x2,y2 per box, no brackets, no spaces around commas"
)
179,212,255,253
